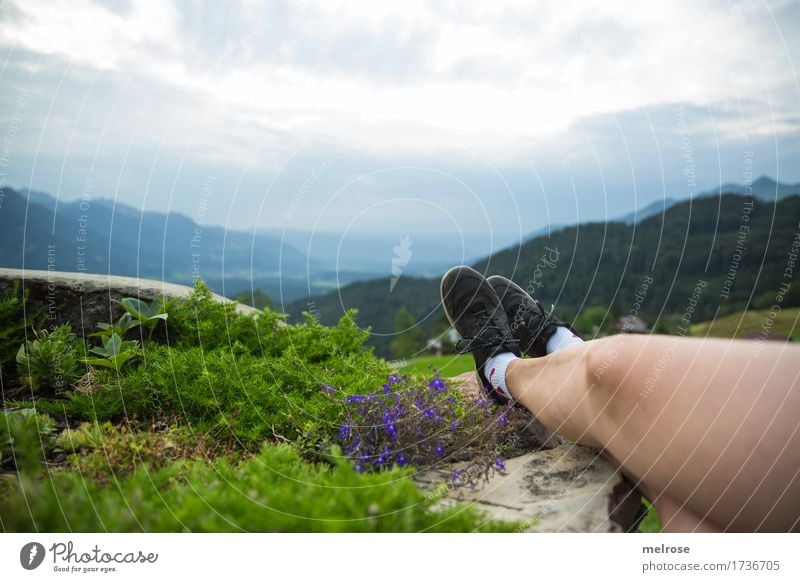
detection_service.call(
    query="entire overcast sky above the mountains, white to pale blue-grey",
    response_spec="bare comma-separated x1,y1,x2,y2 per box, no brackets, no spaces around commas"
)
0,0,800,240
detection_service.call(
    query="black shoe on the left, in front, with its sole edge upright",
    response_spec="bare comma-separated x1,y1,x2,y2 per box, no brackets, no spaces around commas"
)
440,267,520,404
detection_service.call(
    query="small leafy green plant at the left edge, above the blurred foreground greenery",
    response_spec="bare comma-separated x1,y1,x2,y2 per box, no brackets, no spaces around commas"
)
0,408,55,469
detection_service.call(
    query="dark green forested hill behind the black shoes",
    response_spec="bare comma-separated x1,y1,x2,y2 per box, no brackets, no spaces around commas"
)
288,194,800,357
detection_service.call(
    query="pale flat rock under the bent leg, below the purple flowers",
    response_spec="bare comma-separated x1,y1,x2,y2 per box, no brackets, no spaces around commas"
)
416,444,641,532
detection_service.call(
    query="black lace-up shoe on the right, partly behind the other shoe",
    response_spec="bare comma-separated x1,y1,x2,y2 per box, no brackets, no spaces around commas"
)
488,275,578,358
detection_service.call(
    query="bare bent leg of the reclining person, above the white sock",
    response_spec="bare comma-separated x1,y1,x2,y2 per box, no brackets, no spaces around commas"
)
506,335,800,532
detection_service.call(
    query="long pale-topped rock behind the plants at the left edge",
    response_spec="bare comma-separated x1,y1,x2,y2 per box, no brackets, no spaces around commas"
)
0,269,257,337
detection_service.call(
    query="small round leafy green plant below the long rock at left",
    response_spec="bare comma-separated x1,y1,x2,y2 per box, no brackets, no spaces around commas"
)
17,323,85,394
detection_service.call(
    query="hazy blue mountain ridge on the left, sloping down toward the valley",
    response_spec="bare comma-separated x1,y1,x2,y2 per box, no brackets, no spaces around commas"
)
0,188,324,298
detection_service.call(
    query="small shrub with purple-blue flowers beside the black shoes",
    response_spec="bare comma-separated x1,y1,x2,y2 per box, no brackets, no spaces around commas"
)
327,374,518,484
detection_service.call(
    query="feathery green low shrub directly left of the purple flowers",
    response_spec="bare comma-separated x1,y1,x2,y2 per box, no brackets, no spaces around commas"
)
46,334,389,447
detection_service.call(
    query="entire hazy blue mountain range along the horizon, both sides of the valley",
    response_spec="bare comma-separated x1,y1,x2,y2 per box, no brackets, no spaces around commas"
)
0,177,800,320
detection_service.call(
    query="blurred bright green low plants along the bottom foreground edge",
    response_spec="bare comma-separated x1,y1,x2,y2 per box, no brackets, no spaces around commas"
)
0,445,520,532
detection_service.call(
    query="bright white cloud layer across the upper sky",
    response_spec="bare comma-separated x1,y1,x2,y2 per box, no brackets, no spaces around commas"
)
0,0,798,167
